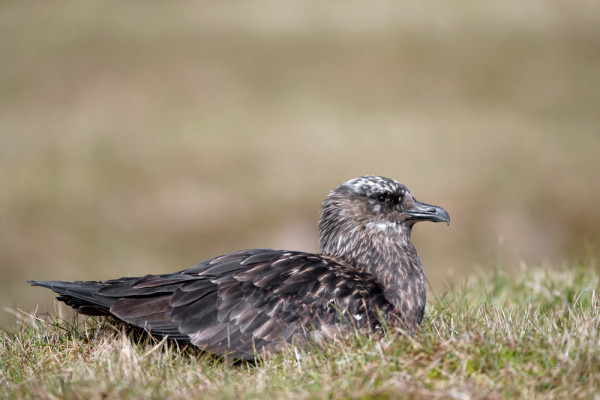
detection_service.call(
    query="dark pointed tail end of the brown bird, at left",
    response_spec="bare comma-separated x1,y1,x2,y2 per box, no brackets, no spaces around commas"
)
27,281,117,315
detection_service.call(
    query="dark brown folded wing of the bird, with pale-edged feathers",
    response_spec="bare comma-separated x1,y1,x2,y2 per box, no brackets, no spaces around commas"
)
33,249,391,359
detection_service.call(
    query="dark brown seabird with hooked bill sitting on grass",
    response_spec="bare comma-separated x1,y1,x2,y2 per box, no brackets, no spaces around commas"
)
28,175,450,360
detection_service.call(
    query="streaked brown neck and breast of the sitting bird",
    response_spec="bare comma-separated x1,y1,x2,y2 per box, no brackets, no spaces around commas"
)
322,228,426,328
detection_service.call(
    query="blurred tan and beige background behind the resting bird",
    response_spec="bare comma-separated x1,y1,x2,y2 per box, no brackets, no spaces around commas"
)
0,0,600,326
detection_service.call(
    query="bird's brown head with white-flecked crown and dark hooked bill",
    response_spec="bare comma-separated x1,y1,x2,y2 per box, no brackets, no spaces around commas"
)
319,175,450,255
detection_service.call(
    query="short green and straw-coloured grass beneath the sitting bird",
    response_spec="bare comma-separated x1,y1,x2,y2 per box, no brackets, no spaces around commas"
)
0,263,600,399
